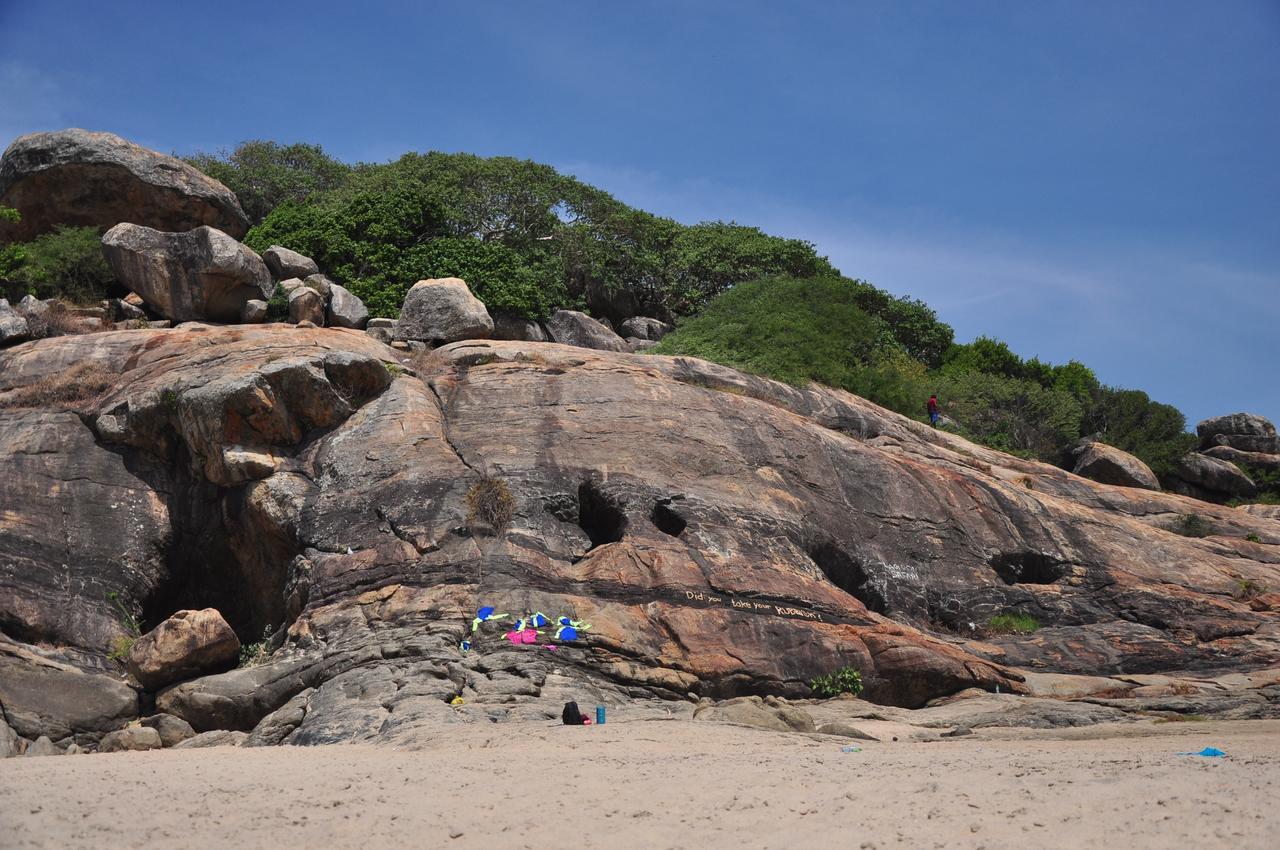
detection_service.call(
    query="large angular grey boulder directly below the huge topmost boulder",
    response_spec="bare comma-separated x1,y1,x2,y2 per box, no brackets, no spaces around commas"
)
102,224,271,321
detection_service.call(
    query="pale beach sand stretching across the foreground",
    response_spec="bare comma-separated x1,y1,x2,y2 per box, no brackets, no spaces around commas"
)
0,718,1280,850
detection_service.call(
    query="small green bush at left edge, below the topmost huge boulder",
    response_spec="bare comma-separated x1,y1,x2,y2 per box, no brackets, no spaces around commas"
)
0,227,115,303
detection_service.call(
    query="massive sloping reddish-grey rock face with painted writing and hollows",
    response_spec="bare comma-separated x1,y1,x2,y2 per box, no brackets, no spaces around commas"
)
0,325,1280,744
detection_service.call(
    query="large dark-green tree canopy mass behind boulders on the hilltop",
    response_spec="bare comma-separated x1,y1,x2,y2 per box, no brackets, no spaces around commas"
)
198,142,824,323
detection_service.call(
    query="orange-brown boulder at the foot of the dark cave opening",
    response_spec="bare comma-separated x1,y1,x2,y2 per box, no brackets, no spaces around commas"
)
129,608,239,690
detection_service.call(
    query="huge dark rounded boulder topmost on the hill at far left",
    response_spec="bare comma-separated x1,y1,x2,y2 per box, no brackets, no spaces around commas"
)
0,129,248,242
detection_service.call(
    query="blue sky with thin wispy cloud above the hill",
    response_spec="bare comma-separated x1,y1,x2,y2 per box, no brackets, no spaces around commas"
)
0,0,1280,425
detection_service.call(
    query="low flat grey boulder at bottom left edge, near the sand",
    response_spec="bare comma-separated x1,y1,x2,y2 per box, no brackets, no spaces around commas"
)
0,654,138,740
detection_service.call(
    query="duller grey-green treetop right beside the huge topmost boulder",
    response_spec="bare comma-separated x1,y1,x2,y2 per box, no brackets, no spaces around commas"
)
186,141,351,224
